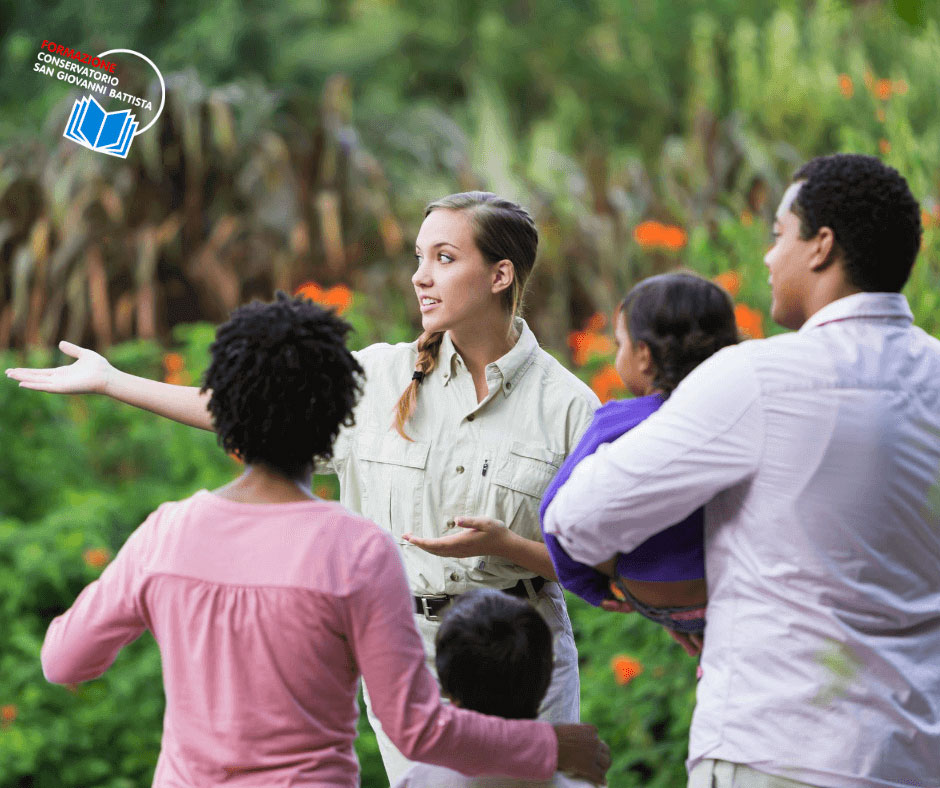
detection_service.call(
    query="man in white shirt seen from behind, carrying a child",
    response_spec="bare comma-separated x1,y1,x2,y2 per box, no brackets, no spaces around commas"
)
545,154,940,788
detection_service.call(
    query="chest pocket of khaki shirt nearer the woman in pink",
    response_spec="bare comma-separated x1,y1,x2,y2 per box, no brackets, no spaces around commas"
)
356,433,431,537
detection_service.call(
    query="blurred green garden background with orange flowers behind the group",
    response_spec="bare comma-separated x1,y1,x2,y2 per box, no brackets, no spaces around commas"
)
0,0,940,788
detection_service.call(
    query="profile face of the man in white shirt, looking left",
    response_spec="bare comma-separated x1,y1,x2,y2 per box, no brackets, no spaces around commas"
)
764,182,812,330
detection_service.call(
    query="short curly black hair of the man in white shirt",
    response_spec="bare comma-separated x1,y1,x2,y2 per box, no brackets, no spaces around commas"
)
791,153,923,293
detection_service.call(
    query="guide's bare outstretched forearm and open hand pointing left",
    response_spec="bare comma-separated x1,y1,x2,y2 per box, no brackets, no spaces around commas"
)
6,342,213,430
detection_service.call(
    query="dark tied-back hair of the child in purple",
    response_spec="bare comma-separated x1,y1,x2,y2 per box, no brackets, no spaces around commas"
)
619,271,740,398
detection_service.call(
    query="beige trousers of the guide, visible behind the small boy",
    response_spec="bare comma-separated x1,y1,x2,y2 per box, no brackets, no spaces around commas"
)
362,583,581,785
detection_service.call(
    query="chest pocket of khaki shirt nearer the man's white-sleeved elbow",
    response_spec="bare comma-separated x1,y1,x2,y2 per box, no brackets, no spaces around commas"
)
491,441,564,541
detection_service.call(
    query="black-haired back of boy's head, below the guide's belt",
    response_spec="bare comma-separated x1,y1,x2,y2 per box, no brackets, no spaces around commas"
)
435,589,552,719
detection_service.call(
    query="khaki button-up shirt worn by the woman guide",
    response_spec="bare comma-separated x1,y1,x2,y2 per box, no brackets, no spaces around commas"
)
317,318,600,594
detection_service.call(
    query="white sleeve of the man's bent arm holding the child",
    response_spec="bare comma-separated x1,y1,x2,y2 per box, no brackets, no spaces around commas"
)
545,347,764,566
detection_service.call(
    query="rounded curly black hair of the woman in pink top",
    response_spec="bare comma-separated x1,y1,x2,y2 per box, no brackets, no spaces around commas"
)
200,291,363,479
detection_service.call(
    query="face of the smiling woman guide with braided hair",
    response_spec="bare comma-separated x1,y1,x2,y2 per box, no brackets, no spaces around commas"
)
411,209,512,332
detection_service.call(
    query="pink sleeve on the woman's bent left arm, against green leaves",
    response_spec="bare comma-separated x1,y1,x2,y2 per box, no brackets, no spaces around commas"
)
40,518,149,684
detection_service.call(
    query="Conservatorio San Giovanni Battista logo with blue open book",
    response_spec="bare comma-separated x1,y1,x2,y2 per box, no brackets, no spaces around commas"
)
33,40,166,159
